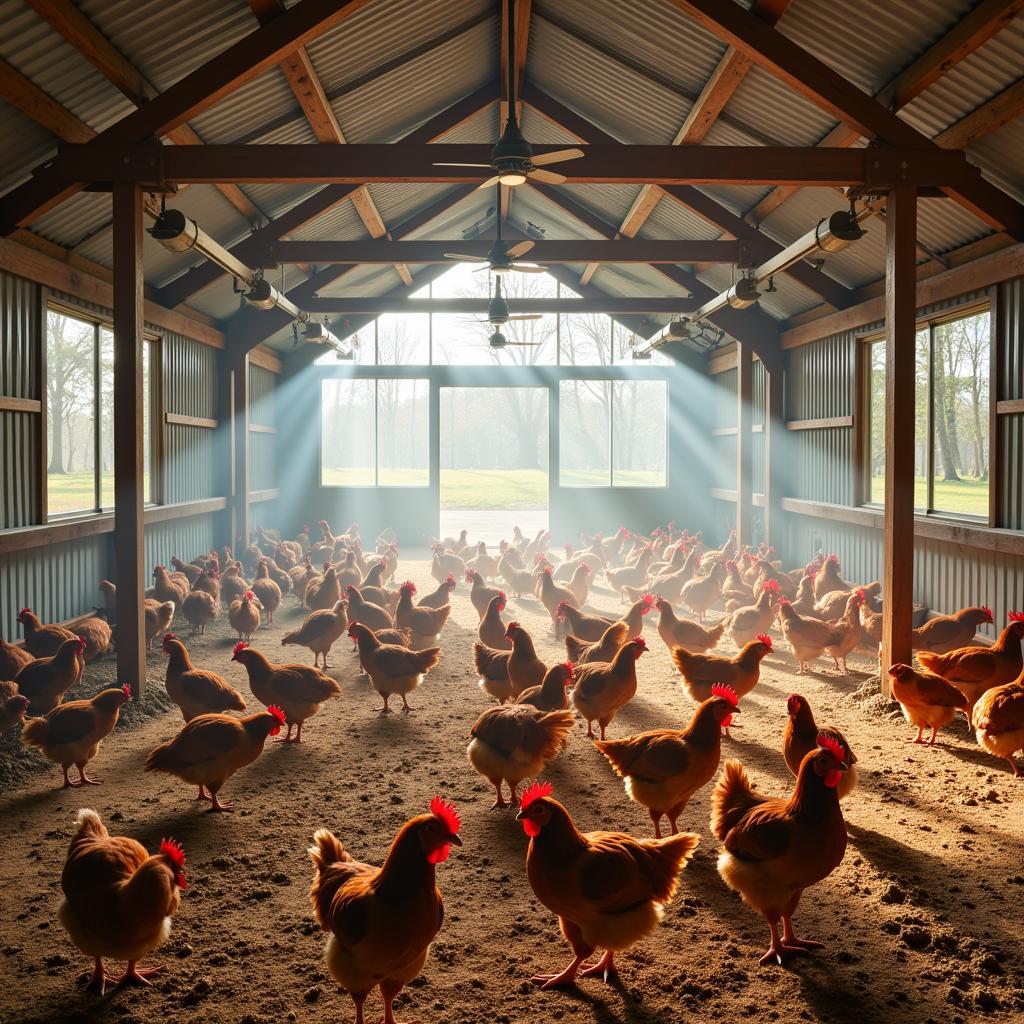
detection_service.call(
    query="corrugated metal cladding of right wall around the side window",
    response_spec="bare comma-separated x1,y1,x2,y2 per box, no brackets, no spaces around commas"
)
785,279,1024,637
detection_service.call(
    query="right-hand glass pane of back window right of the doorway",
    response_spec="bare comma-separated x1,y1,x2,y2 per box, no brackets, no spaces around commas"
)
611,381,669,487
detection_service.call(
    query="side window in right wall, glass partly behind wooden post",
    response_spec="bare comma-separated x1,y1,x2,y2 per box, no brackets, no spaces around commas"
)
865,301,990,517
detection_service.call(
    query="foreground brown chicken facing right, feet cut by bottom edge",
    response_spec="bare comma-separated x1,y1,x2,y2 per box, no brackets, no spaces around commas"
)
309,797,462,1024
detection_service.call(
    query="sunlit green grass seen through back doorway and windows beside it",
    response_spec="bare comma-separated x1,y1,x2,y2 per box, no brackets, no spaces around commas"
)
323,469,665,510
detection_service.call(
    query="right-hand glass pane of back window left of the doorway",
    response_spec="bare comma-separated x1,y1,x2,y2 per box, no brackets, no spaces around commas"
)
377,379,430,487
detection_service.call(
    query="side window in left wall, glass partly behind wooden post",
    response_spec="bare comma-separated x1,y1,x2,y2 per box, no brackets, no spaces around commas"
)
46,301,154,516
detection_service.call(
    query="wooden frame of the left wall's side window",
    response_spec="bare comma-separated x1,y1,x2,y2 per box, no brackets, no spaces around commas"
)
41,295,165,525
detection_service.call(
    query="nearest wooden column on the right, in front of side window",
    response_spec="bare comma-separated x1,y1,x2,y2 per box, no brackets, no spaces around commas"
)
881,185,918,696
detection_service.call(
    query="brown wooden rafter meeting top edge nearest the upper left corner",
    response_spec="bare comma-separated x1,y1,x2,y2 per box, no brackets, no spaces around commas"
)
26,0,264,223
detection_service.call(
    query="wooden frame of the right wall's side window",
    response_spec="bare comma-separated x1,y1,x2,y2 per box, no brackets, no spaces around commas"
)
853,290,996,526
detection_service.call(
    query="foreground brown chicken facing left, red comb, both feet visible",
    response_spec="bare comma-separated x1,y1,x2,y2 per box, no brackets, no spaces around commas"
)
517,782,699,988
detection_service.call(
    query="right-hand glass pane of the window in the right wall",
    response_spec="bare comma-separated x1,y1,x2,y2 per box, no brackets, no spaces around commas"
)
932,310,989,516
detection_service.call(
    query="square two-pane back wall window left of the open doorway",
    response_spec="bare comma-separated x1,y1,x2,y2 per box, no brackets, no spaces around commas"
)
321,378,430,487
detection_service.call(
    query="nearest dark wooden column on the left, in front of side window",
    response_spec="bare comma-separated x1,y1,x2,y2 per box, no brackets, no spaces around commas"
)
114,182,145,697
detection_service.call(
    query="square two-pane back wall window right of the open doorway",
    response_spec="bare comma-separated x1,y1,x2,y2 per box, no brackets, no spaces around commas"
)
558,380,669,487
